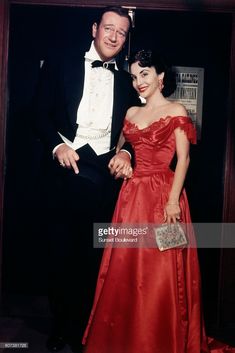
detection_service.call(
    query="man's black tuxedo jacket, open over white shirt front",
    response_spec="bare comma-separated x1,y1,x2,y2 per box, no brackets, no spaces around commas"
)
35,48,140,152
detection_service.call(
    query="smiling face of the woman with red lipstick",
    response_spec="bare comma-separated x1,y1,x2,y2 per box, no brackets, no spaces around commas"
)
130,62,164,98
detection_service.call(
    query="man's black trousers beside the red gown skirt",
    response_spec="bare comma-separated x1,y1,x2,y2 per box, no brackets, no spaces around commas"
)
43,147,121,343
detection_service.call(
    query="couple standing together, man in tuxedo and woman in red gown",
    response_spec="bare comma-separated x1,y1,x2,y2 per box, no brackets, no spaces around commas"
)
35,7,232,353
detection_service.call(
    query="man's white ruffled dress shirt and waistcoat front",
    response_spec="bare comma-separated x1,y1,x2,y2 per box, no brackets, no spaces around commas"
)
56,42,117,155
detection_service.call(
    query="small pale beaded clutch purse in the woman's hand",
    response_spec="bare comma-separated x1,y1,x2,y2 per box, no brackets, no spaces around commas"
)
154,223,188,251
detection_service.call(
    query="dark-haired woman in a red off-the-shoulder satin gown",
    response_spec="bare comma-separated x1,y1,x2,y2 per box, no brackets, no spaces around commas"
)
83,50,235,353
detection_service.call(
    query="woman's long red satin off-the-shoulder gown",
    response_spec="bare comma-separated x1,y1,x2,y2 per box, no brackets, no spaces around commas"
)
83,116,235,353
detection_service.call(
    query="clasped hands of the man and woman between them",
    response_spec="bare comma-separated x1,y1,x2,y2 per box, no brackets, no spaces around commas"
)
108,151,132,179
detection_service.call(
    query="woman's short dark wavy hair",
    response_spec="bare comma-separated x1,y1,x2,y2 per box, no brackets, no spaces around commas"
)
129,49,176,97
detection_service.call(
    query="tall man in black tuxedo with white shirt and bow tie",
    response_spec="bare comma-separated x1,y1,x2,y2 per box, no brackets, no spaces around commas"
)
33,7,139,352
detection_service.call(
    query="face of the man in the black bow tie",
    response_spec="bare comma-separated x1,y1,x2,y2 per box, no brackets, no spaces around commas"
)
92,11,129,61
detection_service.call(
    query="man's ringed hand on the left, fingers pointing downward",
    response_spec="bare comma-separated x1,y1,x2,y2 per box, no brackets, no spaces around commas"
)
55,143,79,174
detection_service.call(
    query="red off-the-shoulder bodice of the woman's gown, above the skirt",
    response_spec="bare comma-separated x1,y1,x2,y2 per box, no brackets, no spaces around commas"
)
123,116,196,175
